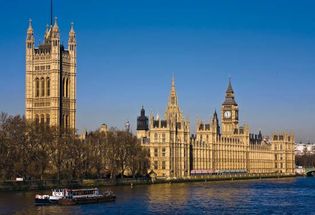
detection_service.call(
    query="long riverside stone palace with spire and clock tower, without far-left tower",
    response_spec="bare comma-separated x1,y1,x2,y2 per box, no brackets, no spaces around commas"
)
137,77,295,178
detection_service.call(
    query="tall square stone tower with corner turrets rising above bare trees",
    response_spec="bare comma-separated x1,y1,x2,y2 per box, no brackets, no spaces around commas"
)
25,19,76,129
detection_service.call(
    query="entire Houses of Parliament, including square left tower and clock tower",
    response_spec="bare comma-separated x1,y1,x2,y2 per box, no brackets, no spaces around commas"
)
25,19,295,178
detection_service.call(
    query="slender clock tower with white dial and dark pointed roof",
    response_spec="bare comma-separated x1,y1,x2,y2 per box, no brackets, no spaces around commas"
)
221,80,238,136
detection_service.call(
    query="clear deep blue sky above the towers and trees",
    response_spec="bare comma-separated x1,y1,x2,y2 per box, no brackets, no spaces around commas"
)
0,0,315,141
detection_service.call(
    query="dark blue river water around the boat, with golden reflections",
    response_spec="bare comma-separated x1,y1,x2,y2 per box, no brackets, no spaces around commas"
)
0,177,315,215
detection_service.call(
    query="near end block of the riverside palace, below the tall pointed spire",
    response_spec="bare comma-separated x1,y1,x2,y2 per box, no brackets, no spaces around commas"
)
137,79,190,178
